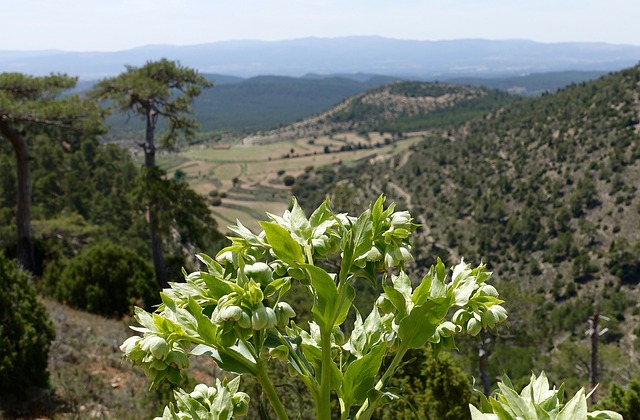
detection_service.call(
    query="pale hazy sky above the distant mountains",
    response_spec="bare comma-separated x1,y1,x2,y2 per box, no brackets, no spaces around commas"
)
5,0,640,51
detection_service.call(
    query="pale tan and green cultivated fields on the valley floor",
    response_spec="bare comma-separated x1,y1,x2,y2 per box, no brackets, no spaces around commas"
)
158,132,426,232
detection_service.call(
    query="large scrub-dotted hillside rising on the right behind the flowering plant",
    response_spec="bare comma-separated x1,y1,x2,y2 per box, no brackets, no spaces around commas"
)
299,67,640,389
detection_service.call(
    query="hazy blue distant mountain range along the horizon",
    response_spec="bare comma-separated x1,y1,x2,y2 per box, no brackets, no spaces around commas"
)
0,36,640,80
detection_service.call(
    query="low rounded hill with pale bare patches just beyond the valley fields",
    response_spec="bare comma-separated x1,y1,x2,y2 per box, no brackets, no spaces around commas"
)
243,81,513,144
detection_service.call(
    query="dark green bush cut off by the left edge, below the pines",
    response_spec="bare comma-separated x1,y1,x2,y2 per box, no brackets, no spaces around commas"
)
0,254,55,400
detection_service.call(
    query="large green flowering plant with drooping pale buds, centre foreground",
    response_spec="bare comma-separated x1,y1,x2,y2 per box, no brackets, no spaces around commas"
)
121,196,507,419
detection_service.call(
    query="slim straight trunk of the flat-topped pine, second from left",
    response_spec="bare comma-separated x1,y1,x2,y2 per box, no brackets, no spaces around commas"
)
143,110,169,289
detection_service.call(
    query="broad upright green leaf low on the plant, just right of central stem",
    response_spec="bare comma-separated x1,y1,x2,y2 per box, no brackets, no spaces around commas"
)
342,343,387,410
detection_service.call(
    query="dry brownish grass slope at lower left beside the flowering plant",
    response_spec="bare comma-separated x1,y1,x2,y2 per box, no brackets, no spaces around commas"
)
34,299,216,419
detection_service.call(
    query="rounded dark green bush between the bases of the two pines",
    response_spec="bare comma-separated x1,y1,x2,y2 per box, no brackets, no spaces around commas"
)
44,243,158,316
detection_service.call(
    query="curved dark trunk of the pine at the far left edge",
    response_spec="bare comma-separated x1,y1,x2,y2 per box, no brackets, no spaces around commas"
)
0,120,36,273
